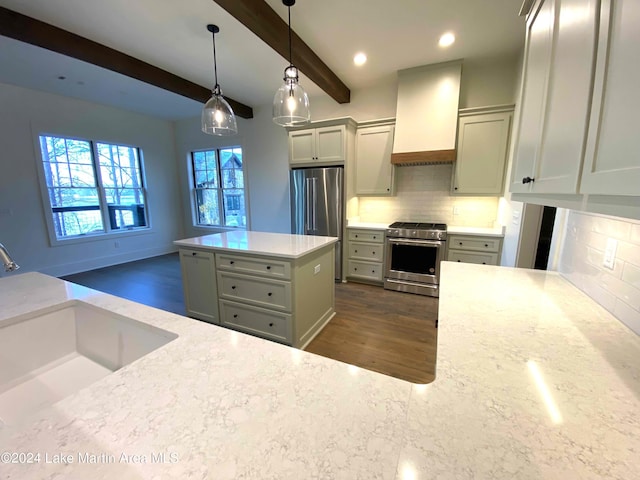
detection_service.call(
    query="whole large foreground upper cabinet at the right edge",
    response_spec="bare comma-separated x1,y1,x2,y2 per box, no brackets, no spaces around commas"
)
510,0,640,210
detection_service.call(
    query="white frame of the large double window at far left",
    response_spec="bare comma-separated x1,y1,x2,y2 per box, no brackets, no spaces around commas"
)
34,131,152,246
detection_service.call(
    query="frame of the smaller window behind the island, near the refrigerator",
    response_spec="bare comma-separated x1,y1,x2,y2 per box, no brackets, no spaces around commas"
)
187,145,249,231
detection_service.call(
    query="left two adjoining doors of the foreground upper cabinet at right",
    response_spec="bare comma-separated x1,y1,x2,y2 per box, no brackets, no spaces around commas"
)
510,0,599,194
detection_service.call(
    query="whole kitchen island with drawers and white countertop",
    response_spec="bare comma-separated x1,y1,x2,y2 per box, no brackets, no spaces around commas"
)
174,230,338,348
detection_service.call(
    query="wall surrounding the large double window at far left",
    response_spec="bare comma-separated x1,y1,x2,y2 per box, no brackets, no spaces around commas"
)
0,84,182,275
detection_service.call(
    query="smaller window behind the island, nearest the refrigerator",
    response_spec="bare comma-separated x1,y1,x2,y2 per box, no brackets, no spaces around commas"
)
191,147,247,228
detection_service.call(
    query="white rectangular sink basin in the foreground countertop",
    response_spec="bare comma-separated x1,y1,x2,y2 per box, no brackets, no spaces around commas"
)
0,301,178,428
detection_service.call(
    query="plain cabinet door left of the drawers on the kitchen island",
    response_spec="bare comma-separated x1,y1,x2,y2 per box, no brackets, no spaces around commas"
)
180,249,220,323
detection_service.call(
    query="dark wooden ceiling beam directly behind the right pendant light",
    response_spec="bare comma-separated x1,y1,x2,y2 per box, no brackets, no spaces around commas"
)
213,0,351,103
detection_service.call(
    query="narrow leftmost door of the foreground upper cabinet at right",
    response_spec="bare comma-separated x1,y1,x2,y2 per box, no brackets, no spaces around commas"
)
510,0,553,192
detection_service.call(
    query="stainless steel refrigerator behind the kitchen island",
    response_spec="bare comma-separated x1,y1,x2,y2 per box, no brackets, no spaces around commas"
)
291,167,344,280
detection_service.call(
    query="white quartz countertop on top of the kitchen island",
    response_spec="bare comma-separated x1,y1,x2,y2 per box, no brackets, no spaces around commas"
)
173,230,338,258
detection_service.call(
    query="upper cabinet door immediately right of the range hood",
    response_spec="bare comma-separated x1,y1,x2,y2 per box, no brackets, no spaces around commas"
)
452,112,511,196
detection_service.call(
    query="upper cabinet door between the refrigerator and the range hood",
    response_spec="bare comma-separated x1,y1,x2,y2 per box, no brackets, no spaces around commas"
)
355,125,394,195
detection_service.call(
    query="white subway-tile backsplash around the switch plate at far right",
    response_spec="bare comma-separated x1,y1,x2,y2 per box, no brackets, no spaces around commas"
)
558,210,640,334
